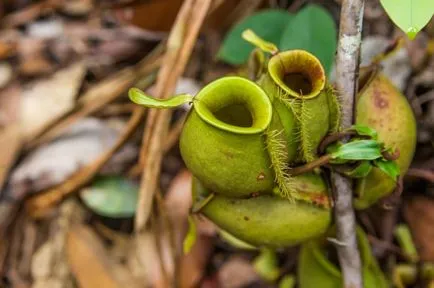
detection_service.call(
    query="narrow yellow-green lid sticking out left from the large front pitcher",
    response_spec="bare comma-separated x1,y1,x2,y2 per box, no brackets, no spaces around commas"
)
128,88,194,108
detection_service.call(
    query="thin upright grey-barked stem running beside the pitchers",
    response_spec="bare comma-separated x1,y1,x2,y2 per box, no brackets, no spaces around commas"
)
332,0,364,288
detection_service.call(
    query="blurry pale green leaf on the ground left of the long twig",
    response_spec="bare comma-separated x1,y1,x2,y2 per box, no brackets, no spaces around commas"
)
80,176,139,218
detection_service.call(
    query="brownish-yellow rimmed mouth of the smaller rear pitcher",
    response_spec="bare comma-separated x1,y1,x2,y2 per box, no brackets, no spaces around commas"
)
268,50,326,99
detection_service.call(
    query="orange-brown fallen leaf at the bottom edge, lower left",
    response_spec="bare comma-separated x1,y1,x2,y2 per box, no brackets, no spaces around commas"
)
66,225,140,288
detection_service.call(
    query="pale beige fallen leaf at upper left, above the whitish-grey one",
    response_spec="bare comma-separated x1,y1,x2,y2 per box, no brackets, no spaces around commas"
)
20,62,86,140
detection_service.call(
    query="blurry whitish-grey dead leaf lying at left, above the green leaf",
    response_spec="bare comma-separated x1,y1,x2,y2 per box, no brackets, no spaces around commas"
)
10,118,124,195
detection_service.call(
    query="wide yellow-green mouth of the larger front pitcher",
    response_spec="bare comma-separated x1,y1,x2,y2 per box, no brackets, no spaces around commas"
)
194,77,273,134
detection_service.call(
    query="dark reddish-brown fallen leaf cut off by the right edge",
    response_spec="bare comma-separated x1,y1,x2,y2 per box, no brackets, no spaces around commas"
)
404,196,434,262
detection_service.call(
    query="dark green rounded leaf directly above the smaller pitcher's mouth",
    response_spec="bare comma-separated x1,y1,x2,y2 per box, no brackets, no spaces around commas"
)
279,4,337,73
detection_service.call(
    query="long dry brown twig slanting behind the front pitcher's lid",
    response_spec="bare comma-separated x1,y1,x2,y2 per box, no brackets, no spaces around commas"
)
135,0,211,231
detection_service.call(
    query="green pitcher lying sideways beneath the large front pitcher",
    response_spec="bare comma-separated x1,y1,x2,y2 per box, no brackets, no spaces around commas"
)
192,173,331,248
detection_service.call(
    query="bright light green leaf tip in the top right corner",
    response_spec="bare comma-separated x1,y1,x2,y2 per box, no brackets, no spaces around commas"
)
380,0,434,39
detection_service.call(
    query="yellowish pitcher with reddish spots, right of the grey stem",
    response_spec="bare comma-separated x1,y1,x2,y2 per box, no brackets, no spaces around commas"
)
354,66,417,209
